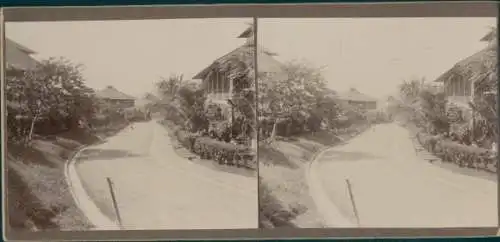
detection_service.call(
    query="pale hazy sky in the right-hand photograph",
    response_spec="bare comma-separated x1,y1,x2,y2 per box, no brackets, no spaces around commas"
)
258,18,496,97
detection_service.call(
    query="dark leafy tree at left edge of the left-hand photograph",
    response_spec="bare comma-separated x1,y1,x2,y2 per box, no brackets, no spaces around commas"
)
5,58,95,144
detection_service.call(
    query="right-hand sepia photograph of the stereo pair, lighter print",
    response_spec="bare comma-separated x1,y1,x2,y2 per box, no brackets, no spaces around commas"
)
257,17,498,229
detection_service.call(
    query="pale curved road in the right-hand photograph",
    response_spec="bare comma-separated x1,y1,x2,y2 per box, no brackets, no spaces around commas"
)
309,123,498,227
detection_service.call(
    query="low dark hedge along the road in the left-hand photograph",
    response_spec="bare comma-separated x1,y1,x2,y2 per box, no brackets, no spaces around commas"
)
174,128,257,170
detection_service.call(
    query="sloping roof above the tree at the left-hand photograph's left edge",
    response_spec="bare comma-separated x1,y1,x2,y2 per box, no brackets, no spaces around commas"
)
5,38,38,70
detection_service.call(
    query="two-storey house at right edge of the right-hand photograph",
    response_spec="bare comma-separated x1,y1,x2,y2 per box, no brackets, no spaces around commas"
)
435,30,498,109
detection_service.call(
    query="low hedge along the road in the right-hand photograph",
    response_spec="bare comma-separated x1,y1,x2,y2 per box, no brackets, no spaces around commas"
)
417,132,498,172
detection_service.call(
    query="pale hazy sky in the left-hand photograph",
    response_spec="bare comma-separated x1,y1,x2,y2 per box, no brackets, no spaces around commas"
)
6,19,252,96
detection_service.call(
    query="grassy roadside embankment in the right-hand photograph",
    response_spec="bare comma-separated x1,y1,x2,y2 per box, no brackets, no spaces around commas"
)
259,127,370,228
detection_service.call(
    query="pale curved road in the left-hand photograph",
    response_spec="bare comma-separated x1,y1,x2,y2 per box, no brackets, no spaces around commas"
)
76,121,258,229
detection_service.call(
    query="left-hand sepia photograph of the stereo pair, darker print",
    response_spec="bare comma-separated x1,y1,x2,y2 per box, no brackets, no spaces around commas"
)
2,18,258,232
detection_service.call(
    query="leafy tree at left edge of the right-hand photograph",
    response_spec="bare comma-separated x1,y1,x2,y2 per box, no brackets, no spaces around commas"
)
258,61,335,139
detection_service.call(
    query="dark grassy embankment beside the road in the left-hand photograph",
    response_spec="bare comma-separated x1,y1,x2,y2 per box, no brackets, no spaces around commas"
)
5,126,127,231
